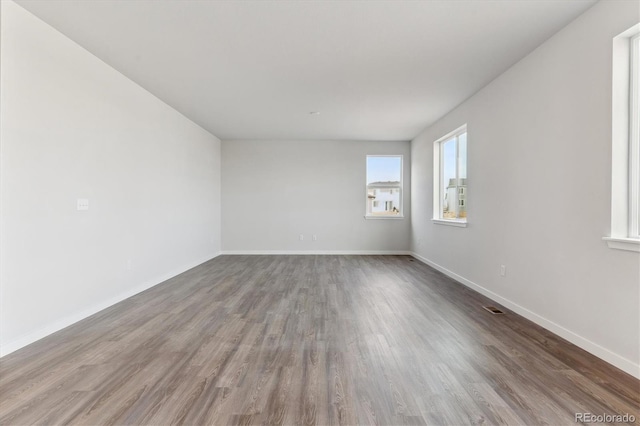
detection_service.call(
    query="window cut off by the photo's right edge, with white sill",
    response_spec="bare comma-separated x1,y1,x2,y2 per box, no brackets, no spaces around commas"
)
604,24,640,252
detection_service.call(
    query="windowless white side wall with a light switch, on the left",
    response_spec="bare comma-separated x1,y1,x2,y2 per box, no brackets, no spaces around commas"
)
0,1,220,354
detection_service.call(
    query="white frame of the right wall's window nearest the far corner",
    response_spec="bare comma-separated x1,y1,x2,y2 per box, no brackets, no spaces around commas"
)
431,123,469,228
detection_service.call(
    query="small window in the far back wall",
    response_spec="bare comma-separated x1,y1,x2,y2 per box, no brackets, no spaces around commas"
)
365,155,403,219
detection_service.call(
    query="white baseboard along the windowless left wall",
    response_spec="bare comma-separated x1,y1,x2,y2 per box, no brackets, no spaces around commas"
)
0,253,220,357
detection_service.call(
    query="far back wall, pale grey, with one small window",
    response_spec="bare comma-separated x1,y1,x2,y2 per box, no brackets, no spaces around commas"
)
222,141,410,253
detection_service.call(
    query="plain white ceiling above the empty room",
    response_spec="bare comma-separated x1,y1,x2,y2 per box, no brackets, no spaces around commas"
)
17,0,595,140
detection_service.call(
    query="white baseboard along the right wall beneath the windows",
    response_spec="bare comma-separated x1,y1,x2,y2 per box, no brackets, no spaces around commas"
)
411,252,640,379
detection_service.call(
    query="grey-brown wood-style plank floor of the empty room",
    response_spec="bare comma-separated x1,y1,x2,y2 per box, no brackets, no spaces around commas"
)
0,256,640,425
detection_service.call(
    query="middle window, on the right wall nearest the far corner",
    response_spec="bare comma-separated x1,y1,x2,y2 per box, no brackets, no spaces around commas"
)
433,124,468,226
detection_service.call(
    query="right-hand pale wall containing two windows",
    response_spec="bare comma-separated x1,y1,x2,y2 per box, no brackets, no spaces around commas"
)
412,1,640,376
